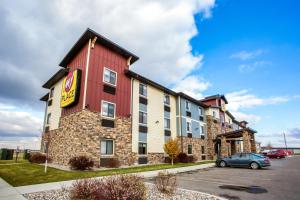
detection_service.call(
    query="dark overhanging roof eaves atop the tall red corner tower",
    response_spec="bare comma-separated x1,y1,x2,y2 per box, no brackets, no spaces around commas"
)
59,28,139,67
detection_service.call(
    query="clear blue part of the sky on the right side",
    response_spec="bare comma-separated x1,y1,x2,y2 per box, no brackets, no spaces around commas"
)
190,0,300,147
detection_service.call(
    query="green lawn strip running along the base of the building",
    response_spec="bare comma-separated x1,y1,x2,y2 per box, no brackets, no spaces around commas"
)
0,161,214,187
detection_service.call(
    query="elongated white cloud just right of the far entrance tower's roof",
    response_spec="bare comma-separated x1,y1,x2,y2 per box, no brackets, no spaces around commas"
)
226,90,290,111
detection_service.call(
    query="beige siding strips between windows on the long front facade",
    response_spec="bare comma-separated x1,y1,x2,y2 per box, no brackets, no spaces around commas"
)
132,80,176,153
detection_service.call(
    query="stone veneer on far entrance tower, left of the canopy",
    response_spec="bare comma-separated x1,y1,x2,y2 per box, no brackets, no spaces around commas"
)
206,115,221,159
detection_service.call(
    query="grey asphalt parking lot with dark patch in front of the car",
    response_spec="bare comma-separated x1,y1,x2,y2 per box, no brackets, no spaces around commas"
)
173,156,300,200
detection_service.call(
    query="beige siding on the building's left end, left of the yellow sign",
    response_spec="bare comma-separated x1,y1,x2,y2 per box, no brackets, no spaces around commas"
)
45,79,63,130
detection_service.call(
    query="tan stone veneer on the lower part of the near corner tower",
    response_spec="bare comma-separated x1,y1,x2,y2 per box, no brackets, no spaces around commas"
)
42,109,136,165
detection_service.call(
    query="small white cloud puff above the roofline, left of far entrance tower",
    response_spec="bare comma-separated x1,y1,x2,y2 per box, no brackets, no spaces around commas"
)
173,76,211,99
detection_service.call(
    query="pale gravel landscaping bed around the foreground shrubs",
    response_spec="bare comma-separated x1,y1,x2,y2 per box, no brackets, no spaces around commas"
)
24,183,221,200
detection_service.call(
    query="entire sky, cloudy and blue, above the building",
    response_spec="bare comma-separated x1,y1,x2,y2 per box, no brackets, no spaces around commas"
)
0,0,300,149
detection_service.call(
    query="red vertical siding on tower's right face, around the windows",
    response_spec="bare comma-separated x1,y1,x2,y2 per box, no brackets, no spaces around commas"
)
86,44,131,117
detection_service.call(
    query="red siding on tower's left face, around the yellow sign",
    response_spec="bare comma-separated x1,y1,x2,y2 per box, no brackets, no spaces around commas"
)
62,42,88,116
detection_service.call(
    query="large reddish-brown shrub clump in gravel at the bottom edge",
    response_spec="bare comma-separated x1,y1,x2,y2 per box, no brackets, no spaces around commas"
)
70,175,146,200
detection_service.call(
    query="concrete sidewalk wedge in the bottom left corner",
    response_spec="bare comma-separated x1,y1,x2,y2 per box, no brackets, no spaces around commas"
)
0,178,26,200
